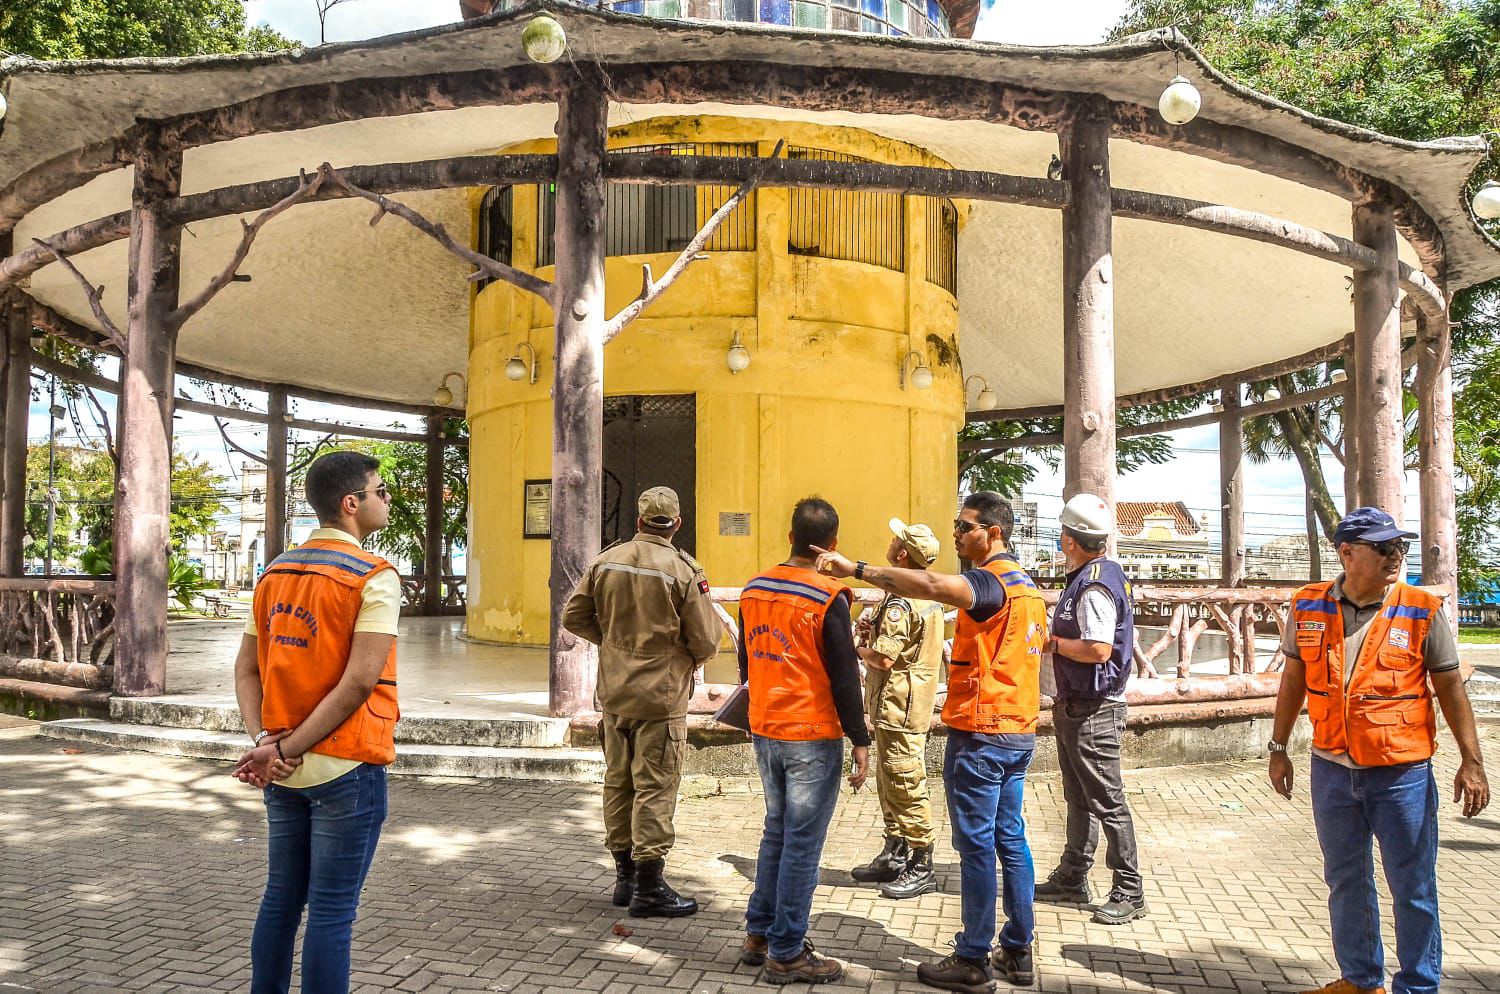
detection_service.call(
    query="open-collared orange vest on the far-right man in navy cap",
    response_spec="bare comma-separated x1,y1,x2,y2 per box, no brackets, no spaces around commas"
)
1292,582,1443,766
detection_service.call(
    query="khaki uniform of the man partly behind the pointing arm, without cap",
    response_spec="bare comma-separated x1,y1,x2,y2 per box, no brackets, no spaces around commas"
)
864,594,944,847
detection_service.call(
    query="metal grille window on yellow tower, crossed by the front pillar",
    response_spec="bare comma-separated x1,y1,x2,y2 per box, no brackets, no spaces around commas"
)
537,142,756,265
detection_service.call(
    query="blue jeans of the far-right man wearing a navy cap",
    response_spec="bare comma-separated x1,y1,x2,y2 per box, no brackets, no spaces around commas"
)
1310,756,1443,994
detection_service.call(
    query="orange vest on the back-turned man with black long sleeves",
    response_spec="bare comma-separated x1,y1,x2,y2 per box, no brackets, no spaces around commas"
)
740,565,854,742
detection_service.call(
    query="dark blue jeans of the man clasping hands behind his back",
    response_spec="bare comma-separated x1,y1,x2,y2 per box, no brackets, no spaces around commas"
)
251,763,386,994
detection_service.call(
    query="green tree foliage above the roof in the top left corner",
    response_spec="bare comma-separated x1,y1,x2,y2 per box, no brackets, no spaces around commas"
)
0,0,297,58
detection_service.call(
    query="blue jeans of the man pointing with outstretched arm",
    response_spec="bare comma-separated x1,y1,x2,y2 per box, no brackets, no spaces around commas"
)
942,729,1037,960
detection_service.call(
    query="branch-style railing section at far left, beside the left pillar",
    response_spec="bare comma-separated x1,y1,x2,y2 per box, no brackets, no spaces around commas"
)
0,579,114,685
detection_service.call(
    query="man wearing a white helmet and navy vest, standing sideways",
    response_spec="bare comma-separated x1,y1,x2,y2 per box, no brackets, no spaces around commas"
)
1037,493,1146,925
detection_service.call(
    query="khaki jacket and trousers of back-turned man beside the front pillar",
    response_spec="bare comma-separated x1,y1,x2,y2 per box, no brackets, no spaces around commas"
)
563,532,723,862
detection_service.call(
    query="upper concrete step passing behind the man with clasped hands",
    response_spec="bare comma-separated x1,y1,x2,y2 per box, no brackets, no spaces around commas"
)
110,697,569,748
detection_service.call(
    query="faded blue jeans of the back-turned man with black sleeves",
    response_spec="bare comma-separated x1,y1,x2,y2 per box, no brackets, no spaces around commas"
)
746,735,843,960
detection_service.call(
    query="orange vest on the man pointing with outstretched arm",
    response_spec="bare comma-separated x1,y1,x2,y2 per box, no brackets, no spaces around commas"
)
942,553,1047,735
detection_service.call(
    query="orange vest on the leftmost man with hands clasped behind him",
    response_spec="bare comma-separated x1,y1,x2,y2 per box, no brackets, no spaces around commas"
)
255,540,401,766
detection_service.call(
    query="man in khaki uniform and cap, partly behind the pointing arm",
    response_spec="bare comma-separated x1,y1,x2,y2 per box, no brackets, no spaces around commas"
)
854,517,944,898
